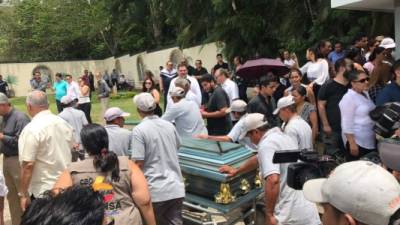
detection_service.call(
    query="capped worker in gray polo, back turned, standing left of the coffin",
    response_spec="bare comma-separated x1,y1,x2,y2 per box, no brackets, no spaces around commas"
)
132,93,185,225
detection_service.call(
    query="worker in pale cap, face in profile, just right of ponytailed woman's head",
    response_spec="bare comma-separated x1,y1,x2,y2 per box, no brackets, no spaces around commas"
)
104,107,132,157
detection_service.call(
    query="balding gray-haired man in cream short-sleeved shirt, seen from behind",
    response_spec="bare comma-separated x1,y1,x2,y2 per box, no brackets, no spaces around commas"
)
18,90,74,210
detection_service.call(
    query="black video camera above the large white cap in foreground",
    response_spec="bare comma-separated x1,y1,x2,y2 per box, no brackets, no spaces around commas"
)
272,150,338,190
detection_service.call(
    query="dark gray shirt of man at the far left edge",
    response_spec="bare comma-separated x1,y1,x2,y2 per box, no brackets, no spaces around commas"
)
1,108,30,156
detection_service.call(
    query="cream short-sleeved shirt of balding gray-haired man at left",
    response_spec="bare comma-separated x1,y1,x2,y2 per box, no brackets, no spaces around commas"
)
18,110,74,196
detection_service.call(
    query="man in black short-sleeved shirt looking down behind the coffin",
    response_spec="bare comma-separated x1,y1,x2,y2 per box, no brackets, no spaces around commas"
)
201,74,232,135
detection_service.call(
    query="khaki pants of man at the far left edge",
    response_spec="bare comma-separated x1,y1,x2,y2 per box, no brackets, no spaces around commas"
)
3,156,22,225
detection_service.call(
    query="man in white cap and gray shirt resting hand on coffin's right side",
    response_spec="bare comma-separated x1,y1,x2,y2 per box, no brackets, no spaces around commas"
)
236,113,320,225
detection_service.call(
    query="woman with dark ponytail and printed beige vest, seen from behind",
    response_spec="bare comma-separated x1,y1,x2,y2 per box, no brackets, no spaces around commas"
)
55,124,155,225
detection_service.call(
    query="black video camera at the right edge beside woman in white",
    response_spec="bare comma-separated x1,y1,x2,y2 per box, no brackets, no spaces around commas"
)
370,102,400,138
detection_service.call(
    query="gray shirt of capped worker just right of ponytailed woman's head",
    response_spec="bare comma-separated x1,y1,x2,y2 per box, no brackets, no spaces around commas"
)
104,124,132,156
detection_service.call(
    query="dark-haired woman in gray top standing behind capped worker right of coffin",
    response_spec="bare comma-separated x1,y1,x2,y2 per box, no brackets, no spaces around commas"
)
292,85,318,144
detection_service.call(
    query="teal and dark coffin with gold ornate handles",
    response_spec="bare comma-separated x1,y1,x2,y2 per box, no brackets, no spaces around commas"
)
178,138,261,204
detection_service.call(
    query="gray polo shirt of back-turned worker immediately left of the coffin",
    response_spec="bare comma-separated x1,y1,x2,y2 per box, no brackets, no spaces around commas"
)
132,115,185,202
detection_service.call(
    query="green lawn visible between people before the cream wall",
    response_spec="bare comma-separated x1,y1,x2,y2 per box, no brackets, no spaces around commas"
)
11,92,155,124
